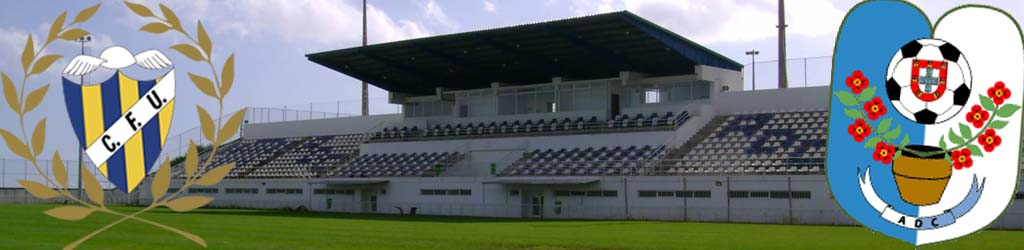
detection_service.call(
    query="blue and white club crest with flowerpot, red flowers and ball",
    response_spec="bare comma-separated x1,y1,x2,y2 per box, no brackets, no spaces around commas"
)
826,1,1024,245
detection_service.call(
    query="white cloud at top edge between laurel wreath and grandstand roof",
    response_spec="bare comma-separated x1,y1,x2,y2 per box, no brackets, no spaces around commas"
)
125,0,432,47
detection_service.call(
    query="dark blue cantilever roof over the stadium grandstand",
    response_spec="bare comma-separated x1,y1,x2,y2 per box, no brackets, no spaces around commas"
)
306,11,742,94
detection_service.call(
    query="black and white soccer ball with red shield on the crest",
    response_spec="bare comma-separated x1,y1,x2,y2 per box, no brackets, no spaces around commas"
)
886,38,971,124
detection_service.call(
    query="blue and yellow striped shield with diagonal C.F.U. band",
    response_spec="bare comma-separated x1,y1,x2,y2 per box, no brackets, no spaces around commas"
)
63,70,174,193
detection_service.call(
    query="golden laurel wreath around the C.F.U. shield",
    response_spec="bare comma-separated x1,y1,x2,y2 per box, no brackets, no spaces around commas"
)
0,1,245,249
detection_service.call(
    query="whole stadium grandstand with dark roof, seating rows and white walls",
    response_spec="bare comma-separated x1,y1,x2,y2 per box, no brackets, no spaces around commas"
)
110,11,1024,228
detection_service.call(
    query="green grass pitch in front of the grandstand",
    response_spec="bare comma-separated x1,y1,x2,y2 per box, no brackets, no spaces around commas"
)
0,205,1024,250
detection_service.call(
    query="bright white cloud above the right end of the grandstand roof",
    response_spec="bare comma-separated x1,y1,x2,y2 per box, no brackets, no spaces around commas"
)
571,0,846,44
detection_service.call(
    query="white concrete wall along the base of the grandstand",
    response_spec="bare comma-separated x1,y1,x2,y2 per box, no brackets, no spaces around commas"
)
130,175,1024,230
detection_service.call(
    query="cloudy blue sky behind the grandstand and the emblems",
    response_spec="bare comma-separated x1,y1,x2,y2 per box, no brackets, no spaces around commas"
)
0,0,1024,161
